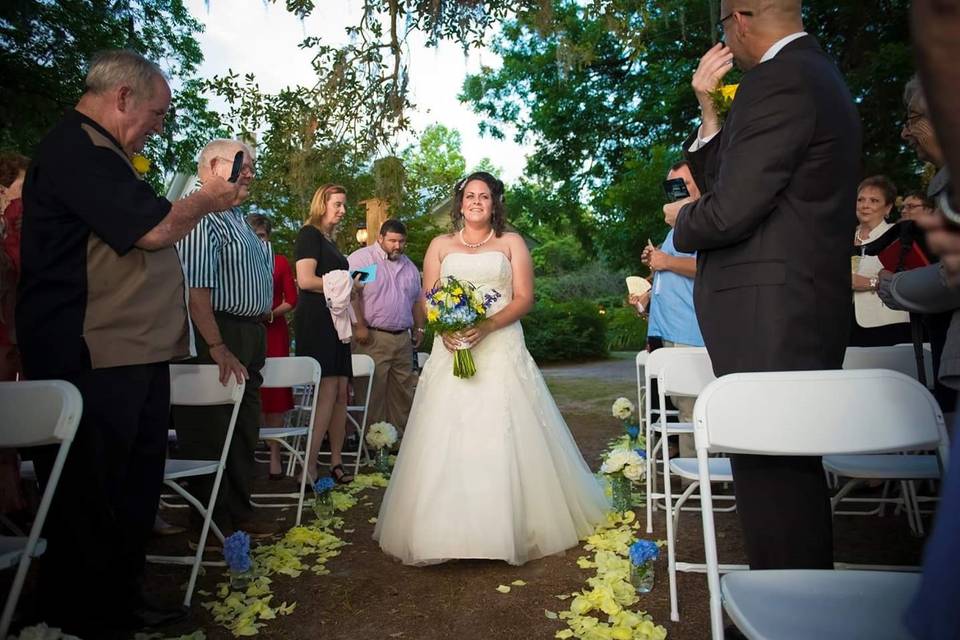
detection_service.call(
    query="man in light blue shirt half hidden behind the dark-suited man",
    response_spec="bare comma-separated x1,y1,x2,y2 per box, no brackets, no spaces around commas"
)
640,160,703,458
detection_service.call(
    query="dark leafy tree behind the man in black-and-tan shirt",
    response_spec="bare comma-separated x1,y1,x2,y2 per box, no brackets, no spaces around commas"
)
0,0,225,186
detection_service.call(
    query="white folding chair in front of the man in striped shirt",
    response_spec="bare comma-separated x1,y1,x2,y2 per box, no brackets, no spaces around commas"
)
147,364,245,607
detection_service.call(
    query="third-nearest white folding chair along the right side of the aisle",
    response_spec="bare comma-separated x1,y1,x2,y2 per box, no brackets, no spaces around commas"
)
637,347,707,533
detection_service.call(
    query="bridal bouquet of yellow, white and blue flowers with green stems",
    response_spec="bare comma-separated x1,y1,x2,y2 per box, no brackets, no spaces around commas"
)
426,276,500,378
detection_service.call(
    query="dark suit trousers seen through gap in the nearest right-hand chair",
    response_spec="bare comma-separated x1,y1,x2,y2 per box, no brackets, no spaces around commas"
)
730,455,833,569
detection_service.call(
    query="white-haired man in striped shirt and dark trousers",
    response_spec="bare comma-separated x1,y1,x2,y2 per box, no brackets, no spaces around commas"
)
173,140,273,537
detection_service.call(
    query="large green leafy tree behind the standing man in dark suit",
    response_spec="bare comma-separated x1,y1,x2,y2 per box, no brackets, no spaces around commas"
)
461,0,918,267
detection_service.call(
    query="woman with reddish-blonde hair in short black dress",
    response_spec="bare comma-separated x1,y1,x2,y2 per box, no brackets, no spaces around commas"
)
294,184,353,484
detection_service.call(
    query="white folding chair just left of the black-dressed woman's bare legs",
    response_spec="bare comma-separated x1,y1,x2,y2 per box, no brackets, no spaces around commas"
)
251,356,320,526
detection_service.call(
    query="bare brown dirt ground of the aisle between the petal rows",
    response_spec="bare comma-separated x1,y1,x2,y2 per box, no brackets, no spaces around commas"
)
141,354,921,640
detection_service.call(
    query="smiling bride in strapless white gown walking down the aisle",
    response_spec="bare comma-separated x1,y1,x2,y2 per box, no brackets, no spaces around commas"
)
373,172,609,565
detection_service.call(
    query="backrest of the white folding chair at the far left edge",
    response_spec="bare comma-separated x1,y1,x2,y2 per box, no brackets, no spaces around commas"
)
0,380,83,447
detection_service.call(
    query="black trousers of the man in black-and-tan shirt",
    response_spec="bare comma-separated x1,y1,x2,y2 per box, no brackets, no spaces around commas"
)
34,362,170,637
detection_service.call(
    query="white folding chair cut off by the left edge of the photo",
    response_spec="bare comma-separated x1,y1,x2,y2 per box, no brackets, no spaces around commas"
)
0,380,83,638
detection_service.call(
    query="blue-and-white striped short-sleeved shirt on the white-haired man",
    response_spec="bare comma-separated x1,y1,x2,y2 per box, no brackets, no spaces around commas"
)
177,208,273,316
